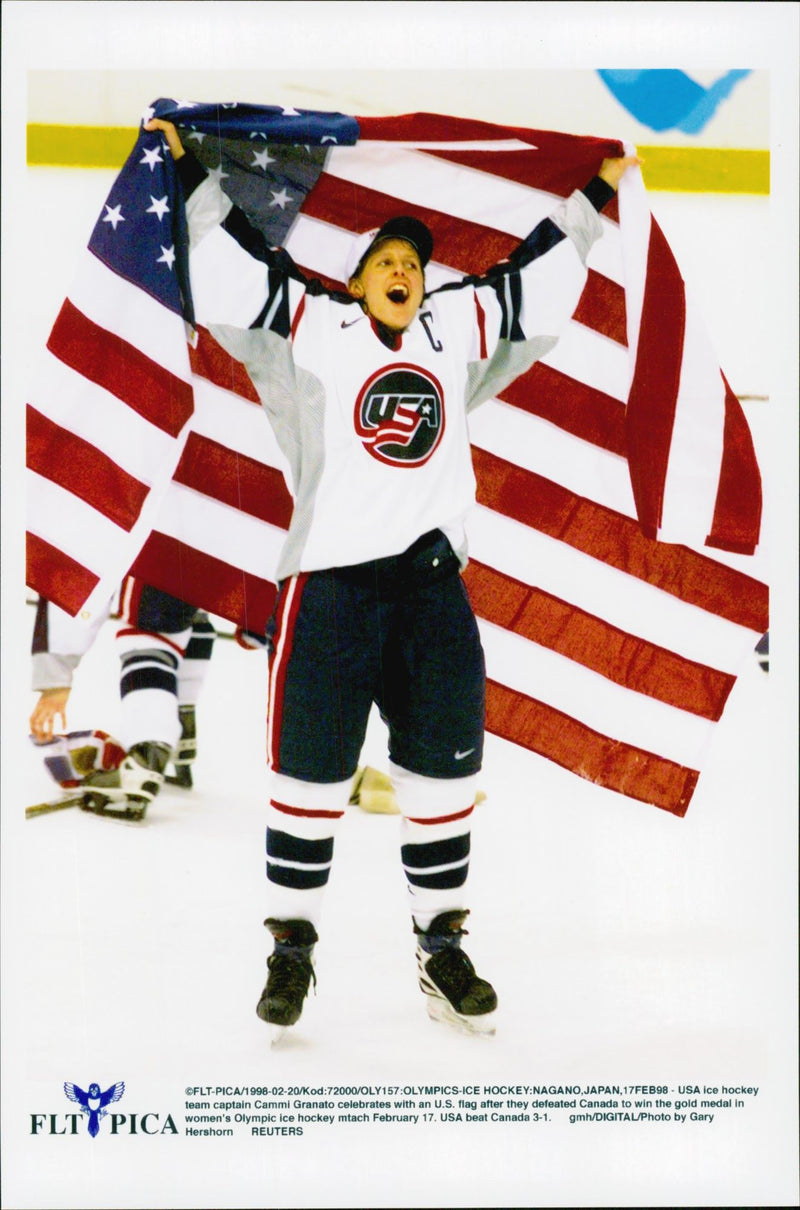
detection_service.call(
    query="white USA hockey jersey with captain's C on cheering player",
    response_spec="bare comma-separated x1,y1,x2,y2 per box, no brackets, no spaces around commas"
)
179,156,608,580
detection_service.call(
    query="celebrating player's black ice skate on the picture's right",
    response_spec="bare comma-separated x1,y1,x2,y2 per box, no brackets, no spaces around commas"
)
414,911,497,1033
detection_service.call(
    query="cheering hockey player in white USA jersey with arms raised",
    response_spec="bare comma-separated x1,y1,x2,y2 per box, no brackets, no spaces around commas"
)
145,119,637,1032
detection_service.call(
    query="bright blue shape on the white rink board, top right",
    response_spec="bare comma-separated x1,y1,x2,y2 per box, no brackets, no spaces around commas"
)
598,69,750,134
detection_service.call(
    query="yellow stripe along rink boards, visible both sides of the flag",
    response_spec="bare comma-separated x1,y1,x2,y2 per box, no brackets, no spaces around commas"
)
28,122,770,194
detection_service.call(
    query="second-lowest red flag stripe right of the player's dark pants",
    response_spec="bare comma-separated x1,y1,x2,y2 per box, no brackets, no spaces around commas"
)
464,559,736,721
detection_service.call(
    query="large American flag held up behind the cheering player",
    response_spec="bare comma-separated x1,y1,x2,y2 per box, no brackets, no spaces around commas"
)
28,99,767,816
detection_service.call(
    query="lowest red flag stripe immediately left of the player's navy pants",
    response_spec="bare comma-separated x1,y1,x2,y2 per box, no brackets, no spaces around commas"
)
131,530,276,634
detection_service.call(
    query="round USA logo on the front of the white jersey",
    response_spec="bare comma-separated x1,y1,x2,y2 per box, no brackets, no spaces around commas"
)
355,365,444,466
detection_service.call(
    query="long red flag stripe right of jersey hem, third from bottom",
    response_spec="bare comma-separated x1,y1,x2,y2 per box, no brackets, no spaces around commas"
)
472,445,767,634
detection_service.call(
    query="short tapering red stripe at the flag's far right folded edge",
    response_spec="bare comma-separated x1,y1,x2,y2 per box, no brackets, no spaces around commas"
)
706,374,761,554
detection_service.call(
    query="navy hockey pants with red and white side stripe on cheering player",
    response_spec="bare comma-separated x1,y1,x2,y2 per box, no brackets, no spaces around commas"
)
267,530,485,783
